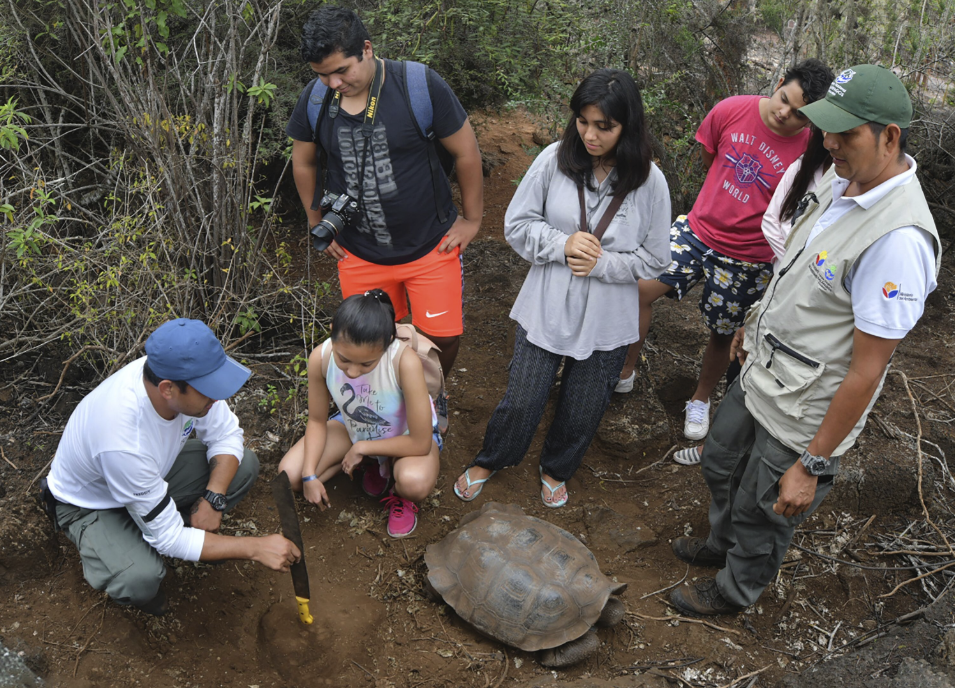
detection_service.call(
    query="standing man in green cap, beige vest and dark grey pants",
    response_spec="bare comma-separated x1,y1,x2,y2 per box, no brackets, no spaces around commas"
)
671,65,941,614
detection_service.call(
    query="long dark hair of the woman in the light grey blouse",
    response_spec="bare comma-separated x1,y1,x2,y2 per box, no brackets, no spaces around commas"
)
557,69,652,196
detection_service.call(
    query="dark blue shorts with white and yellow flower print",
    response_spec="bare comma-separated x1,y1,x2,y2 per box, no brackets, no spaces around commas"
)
657,215,773,334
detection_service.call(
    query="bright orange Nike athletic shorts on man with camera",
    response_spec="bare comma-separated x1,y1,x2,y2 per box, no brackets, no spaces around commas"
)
338,247,464,337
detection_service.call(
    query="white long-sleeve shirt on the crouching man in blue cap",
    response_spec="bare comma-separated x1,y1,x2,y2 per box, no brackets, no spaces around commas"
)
48,357,244,561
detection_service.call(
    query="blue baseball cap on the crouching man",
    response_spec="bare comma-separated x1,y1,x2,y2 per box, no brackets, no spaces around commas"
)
146,318,252,399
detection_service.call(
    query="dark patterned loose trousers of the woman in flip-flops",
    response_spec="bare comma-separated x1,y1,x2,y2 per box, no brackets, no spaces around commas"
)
471,325,627,481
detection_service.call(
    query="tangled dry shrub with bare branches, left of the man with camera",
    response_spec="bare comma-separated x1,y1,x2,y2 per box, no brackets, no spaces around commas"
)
0,0,315,384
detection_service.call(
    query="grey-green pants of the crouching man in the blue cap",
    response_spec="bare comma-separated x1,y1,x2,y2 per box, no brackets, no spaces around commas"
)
56,440,259,606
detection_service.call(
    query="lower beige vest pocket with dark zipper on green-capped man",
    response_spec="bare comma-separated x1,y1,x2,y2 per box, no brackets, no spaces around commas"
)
746,332,826,419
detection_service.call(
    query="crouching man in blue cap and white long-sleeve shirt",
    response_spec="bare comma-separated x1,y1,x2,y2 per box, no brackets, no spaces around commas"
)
44,319,301,616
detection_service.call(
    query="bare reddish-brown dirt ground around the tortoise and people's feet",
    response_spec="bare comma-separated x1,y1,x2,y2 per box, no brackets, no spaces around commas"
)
0,112,955,688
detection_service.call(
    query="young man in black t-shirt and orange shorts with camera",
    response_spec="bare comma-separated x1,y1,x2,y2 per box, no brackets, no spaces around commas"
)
286,5,484,372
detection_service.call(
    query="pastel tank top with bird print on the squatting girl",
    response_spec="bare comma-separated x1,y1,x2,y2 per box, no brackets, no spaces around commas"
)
322,339,408,444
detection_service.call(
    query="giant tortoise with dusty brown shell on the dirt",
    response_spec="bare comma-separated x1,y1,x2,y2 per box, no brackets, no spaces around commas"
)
424,502,626,667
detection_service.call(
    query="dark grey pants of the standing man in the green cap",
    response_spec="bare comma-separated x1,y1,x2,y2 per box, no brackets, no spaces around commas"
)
701,381,839,607
